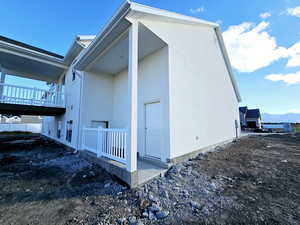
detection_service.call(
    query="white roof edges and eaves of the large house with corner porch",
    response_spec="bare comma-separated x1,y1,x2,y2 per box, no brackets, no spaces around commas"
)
75,0,241,102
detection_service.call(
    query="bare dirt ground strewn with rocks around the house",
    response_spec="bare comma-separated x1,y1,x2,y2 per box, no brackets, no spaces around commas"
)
0,134,300,225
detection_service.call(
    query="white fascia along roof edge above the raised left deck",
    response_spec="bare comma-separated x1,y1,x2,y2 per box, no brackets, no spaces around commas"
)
0,41,68,69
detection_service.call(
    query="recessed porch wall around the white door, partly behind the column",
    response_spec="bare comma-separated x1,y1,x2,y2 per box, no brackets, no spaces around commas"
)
111,47,170,161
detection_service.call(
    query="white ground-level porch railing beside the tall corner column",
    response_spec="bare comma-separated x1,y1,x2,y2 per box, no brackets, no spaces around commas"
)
82,128,127,164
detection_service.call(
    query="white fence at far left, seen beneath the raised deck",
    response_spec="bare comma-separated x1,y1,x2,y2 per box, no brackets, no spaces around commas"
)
0,123,42,133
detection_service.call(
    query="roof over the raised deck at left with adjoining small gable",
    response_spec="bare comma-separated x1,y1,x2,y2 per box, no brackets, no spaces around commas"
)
0,35,94,82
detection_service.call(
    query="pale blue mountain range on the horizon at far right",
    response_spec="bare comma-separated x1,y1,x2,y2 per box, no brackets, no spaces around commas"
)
261,113,300,123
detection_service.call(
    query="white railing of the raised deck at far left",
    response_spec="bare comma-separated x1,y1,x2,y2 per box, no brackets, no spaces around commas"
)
0,83,64,107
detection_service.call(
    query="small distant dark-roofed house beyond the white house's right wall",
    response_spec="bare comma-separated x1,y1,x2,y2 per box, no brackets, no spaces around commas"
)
239,106,262,129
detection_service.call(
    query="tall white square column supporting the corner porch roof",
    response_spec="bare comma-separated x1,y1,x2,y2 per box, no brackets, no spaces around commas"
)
126,21,138,172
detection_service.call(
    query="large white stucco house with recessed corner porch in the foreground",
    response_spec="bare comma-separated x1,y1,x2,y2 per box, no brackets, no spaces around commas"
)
0,1,240,186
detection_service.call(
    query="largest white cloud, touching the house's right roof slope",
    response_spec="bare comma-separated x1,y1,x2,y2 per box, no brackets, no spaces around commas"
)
223,21,288,72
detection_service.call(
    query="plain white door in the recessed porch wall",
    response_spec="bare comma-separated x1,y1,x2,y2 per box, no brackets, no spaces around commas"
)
145,102,162,159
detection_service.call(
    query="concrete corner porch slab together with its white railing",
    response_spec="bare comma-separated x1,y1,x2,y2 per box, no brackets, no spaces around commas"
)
82,128,168,187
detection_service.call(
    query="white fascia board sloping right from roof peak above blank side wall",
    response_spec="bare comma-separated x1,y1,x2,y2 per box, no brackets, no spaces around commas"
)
130,2,219,27
